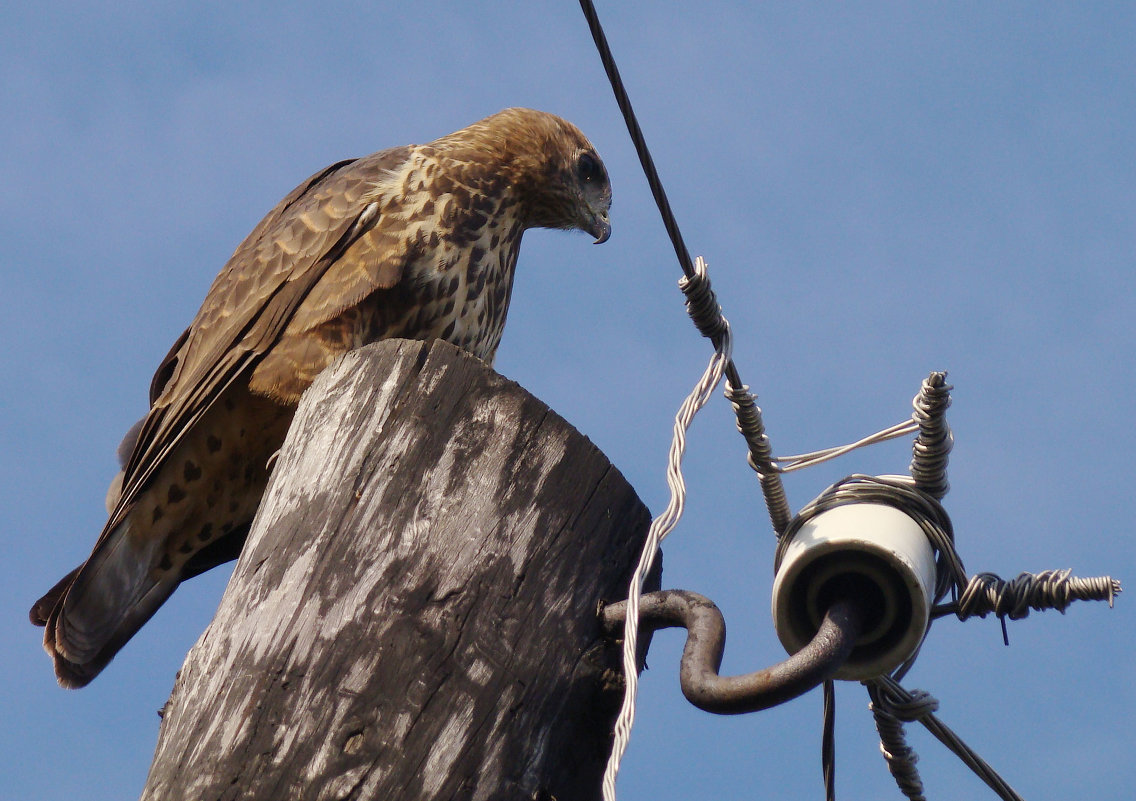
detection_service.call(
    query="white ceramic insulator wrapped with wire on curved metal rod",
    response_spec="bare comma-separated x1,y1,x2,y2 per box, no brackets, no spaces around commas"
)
772,503,935,681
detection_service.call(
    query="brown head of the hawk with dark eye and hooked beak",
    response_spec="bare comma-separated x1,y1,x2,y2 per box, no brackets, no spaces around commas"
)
438,108,611,244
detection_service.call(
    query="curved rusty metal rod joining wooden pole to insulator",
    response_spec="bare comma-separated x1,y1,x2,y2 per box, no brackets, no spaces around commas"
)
602,590,862,715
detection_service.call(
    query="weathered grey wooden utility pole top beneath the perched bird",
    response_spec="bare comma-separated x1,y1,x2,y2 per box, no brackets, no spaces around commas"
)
142,341,649,801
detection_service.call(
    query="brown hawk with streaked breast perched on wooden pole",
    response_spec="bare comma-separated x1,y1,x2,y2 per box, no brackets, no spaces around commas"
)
31,108,611,687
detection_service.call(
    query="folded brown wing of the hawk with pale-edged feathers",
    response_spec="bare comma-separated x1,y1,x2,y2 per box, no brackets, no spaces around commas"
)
107,148,410,531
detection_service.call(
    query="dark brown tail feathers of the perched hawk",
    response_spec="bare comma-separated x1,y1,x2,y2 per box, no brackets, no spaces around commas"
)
31,517,181,687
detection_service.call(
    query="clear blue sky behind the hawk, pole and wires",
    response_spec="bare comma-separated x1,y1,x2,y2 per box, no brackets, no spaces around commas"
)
0,0,1136,801
